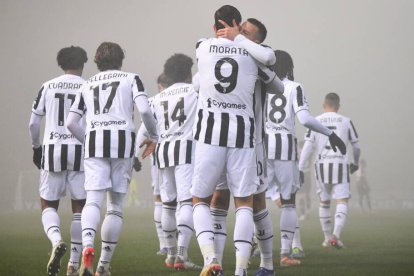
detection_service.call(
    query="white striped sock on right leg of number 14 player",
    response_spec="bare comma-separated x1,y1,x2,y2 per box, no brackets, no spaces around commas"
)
177,202,194,260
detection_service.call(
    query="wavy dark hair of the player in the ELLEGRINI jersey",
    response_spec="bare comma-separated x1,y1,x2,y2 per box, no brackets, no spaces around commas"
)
95,42,125,71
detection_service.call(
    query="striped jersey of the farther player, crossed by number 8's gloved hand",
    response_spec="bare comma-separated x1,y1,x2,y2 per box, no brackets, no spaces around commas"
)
305,112,358,184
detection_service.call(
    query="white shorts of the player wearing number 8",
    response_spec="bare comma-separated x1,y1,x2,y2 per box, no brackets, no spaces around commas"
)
267,159,300,200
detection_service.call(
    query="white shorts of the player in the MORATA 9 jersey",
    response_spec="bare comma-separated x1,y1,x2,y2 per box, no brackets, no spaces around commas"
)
191,142,259,198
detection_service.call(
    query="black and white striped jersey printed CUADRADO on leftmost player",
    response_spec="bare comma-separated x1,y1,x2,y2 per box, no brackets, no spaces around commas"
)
32,74,85,172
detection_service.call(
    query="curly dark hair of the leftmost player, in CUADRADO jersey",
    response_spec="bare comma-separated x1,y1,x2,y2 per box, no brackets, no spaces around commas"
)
56,46,88,71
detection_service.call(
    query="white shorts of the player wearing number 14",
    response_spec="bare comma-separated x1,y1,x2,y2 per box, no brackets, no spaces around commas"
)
159,164,193,202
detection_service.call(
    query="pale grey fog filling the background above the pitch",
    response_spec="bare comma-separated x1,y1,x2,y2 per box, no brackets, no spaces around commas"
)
0,0,414,210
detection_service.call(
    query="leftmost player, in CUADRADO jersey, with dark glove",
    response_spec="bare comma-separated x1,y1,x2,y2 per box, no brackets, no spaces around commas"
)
29,46,88,275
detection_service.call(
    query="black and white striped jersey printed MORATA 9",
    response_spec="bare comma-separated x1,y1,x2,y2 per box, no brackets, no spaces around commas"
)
193,38,259,148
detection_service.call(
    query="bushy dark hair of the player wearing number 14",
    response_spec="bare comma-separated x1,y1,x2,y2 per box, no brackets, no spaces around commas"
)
164,54,193,83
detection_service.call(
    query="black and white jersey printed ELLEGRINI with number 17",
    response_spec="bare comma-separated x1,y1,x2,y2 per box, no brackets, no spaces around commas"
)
70,70,147,158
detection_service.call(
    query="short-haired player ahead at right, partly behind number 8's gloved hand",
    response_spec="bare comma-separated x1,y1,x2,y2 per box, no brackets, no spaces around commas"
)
299,93,361,249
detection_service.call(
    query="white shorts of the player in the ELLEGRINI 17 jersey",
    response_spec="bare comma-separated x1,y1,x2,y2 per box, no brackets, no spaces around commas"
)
84,157,134,194
